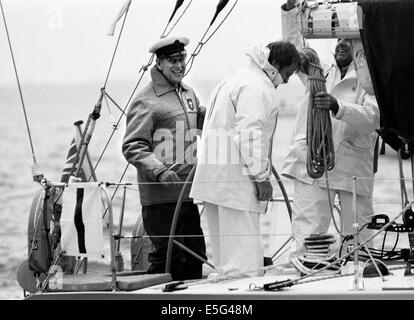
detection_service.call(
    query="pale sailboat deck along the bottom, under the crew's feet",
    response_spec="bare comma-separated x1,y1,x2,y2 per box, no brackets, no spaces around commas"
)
28,269,414,300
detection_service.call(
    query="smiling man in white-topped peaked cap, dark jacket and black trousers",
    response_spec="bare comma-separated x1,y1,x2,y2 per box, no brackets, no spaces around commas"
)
122,37,206,280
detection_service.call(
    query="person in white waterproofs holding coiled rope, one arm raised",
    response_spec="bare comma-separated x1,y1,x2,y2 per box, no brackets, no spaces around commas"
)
282,0,379,254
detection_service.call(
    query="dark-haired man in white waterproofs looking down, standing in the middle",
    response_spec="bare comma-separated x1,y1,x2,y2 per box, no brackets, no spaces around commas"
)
190,41,300,277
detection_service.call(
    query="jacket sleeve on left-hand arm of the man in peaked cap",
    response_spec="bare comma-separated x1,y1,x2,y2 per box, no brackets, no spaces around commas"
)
122,100,167,181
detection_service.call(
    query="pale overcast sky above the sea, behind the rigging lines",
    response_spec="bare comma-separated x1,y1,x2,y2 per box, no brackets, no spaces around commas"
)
0,0,332,86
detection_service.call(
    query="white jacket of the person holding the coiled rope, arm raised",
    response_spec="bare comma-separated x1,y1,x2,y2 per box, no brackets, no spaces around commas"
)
282,9,379,196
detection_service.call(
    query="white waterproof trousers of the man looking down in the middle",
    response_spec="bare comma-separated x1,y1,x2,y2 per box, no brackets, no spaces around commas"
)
203,202,263,278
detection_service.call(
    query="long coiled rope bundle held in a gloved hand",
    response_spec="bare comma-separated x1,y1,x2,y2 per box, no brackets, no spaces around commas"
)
300,48,335,179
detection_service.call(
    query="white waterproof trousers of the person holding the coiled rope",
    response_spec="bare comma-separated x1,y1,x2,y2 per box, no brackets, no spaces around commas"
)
292,180,374,253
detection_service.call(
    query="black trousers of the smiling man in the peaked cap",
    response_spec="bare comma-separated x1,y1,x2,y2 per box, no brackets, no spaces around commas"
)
142,202,207,280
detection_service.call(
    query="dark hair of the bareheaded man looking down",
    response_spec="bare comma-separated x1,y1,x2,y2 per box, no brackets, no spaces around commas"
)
267,41,300,69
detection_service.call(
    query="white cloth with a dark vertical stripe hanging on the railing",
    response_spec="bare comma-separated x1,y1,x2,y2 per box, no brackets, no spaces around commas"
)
60,182,104,257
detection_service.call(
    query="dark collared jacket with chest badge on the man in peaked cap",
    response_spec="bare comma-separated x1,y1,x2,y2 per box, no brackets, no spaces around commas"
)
122,67,205,205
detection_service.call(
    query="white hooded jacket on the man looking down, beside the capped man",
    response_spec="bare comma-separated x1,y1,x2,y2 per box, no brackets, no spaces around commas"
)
190,46,279,213
